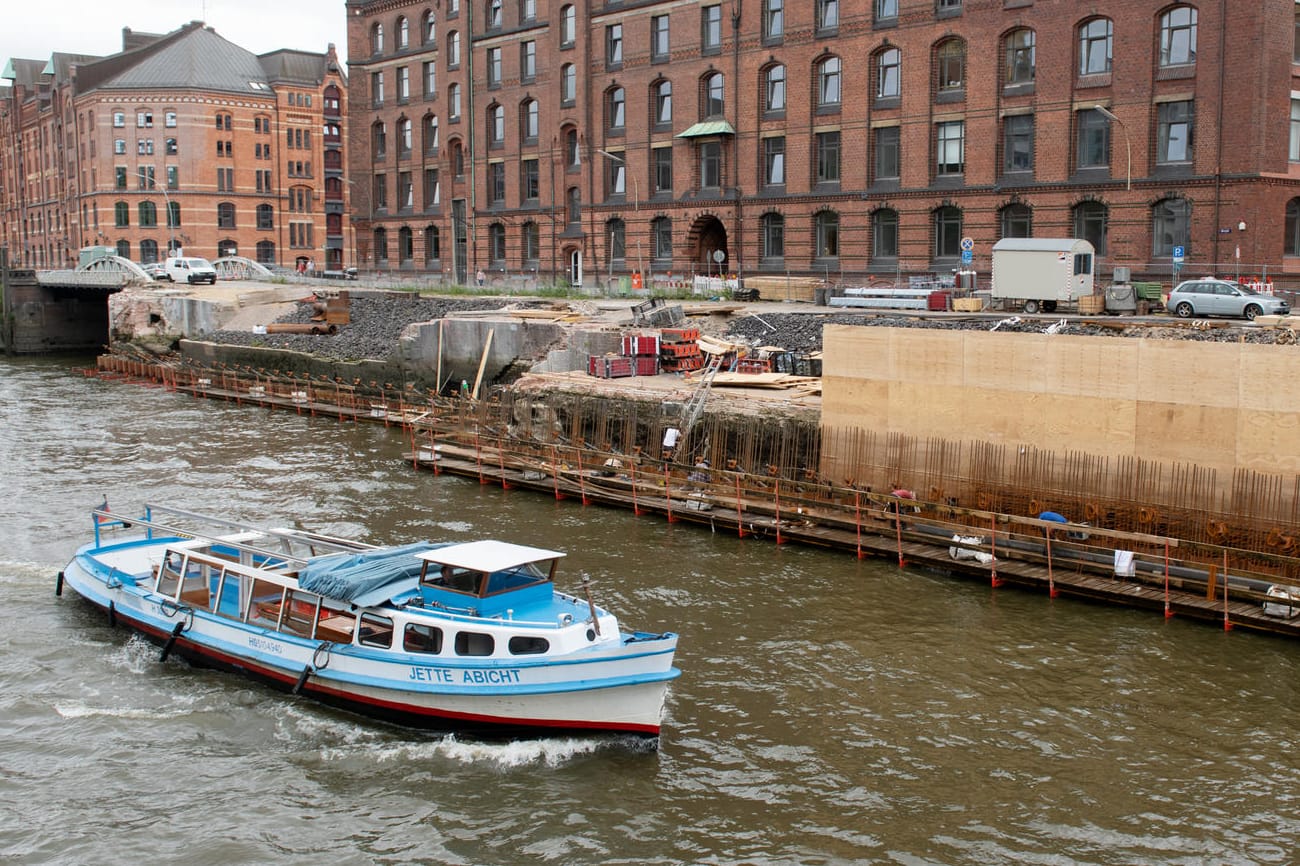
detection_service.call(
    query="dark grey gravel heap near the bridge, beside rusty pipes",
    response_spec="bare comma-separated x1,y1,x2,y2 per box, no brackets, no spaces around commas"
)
207,295,527,360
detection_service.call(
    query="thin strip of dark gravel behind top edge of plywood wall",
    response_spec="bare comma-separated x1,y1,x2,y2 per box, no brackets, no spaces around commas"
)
727,313,1296,352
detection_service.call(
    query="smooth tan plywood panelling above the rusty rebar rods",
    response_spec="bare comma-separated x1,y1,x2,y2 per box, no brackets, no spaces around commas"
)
822,326,1300,496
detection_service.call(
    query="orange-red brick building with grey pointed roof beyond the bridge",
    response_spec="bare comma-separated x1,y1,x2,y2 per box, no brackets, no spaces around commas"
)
0,22,350,269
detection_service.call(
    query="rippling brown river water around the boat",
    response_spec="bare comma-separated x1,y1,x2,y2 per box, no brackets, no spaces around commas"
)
0,359,1300,866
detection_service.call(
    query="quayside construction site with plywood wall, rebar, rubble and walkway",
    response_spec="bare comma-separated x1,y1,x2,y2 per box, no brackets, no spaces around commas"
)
86,282,1300,637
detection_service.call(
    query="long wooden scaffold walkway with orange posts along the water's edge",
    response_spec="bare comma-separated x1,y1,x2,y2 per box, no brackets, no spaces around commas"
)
89,351,1300,637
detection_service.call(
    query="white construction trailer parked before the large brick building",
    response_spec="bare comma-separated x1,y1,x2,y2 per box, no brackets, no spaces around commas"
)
991,238,1097,313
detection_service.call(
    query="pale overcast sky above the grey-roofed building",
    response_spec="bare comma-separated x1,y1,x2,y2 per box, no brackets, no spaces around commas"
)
0,0,347,68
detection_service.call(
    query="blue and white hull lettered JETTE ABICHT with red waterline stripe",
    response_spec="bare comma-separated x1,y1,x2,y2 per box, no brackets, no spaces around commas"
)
61,547,679,737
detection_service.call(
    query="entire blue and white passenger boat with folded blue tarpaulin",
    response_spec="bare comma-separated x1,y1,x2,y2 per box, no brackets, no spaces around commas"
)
59,505,680,736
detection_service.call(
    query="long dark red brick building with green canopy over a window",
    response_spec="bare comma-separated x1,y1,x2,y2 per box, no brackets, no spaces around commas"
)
347,0,1300,289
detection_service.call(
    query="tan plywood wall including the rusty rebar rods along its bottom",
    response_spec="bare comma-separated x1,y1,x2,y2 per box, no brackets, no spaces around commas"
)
820,325,1300,519
